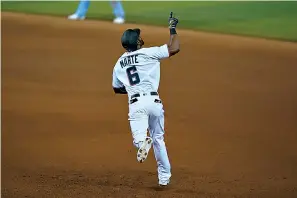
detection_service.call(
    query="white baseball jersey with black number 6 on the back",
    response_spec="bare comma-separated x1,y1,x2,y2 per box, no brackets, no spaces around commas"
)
112,44,169,97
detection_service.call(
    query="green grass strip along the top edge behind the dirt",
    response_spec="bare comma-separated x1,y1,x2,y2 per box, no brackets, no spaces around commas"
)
2,1,297,41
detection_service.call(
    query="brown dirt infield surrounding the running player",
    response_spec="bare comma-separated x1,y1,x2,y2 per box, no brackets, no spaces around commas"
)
1,13,297,198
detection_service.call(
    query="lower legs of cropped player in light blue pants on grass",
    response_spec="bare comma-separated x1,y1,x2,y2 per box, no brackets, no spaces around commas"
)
68,0,125,24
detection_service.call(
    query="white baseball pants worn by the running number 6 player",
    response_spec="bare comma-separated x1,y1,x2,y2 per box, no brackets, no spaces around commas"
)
129,94,171,185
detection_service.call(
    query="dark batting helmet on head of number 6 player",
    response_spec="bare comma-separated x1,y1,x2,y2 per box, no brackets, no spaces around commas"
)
121,29,144,51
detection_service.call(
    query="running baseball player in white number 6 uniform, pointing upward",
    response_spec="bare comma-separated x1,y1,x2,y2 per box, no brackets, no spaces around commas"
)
112,13,179,187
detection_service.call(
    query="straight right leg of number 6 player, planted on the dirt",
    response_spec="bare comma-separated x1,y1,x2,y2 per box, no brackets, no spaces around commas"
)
149,104,171,185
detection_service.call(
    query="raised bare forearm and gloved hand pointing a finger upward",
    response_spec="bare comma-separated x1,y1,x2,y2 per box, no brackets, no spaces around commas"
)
168,12,180,56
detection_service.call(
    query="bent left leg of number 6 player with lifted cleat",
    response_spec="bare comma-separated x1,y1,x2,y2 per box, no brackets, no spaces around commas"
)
129,104,152,162
